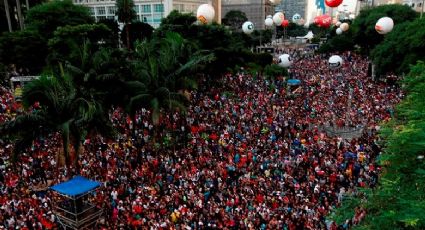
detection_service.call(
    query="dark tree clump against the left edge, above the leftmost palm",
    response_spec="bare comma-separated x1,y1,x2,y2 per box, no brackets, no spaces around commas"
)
0,30,47,73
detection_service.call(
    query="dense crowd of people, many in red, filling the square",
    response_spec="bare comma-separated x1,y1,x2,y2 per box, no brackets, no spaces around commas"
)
0,51,403,230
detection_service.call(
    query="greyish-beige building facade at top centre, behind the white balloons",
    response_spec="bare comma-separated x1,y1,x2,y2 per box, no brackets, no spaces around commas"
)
221,0,274,29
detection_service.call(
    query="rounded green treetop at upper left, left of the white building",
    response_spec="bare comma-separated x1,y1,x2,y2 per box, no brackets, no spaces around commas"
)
26,0,94,38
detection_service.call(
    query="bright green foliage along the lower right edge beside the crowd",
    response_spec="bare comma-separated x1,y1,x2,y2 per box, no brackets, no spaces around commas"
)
337,62,425,229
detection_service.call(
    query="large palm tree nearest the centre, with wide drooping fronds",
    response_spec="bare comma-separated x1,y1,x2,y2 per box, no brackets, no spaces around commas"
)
127,33,213,125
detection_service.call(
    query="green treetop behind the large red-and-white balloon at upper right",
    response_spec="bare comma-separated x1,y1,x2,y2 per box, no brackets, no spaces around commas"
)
350,4,417,53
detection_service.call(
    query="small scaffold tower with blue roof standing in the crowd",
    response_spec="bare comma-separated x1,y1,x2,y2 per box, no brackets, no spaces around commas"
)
51,176,102,230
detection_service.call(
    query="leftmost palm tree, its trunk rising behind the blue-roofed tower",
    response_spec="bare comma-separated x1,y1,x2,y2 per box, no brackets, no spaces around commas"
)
1,76,91,166
